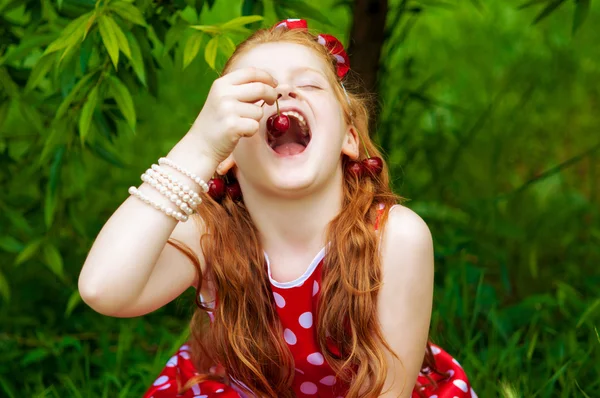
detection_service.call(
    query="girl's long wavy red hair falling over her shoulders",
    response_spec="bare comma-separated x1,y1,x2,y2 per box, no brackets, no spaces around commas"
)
169,29,442,398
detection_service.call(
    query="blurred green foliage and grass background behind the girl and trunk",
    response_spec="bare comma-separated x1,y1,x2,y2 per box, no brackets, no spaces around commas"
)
0,0,600,398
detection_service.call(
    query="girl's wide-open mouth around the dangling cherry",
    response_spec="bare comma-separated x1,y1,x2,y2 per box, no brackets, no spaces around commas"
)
266,110,311,155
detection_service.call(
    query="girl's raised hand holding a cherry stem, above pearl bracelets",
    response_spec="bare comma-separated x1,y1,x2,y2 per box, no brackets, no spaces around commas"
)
188,68,277,163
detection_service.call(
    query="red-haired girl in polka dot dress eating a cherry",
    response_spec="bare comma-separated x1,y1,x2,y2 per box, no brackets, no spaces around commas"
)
79,20,475,398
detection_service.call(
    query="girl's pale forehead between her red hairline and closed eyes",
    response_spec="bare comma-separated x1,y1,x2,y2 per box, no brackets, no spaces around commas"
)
231,42,327,79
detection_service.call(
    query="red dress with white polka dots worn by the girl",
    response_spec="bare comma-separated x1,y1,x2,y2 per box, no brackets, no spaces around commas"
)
144,205,477,398
